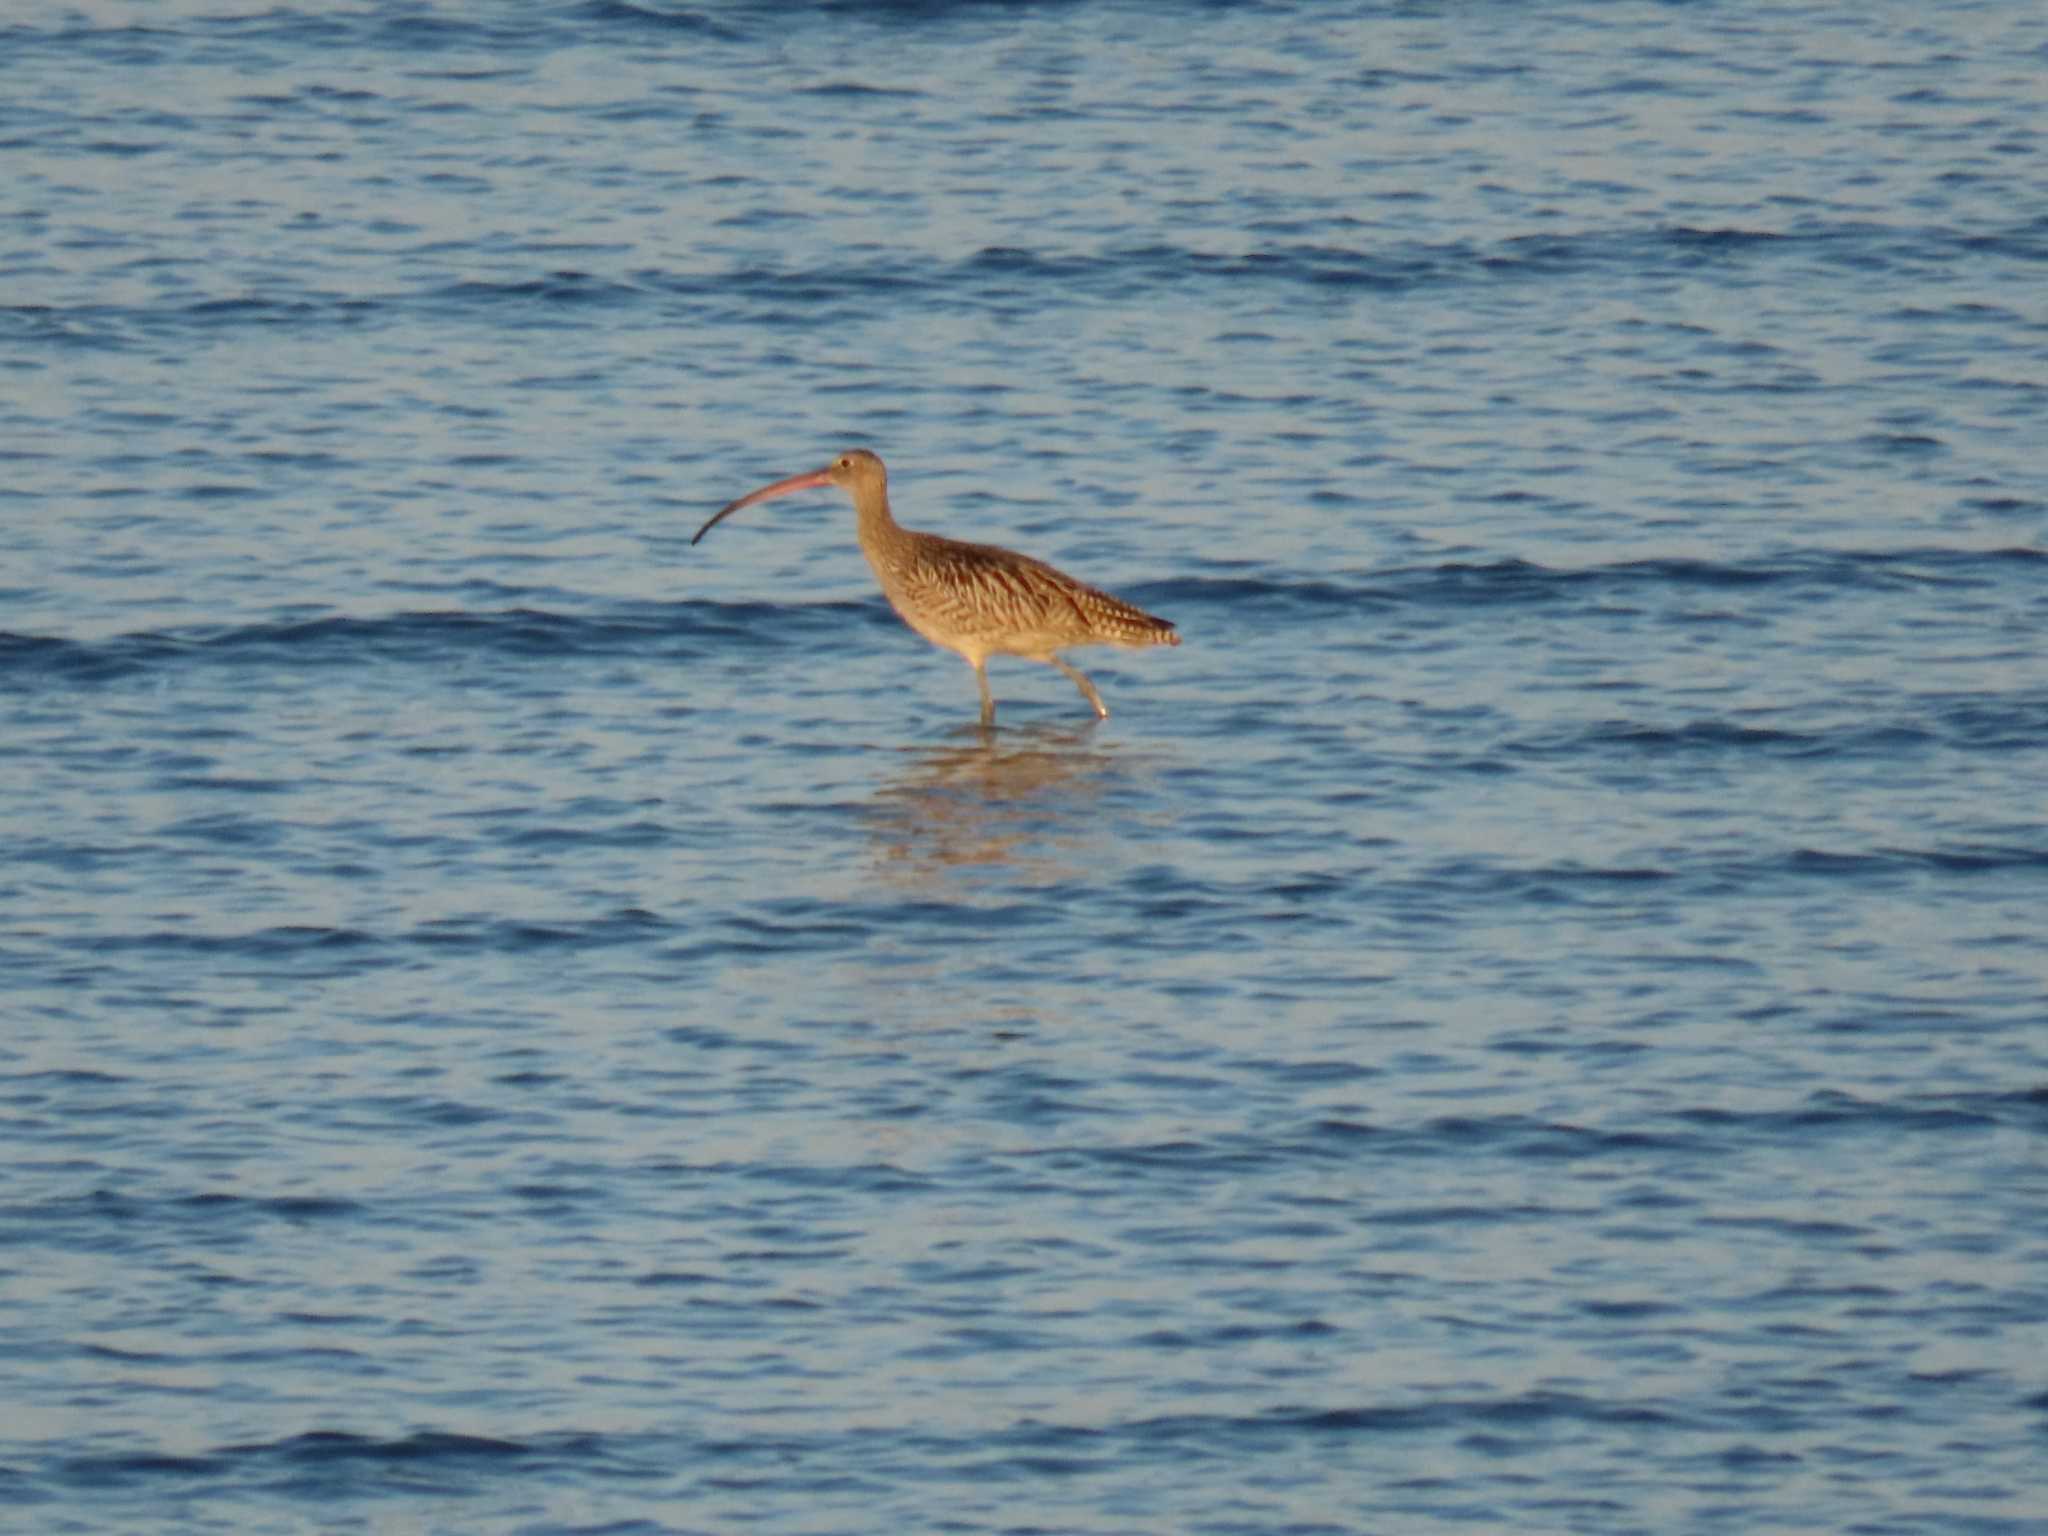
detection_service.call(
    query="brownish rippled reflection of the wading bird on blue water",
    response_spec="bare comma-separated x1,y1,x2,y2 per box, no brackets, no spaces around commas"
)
870,723,1118,885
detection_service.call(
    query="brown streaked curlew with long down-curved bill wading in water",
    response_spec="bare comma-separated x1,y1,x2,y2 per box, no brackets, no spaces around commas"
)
690,449,1180,729
